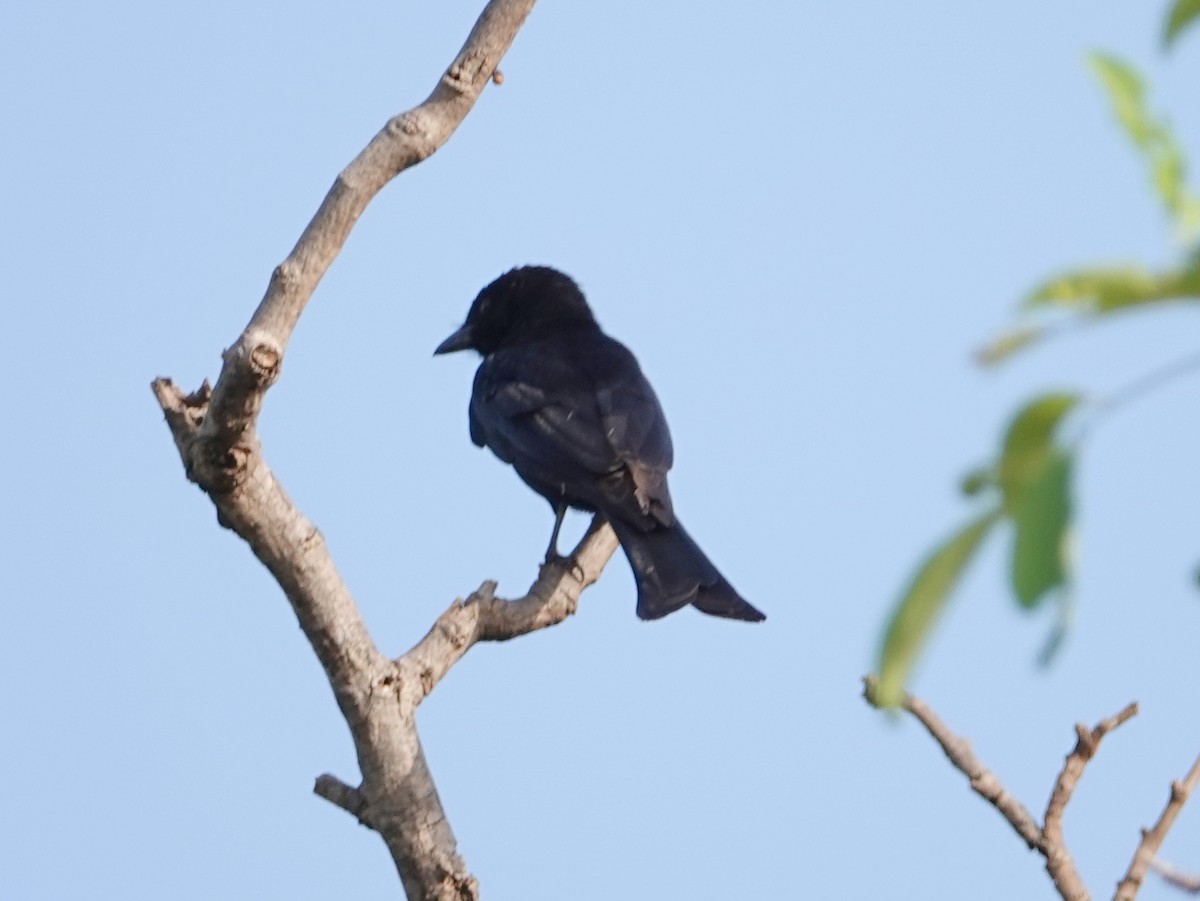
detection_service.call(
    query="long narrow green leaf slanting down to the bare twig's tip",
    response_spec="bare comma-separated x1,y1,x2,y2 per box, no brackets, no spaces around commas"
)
877,507,1001,707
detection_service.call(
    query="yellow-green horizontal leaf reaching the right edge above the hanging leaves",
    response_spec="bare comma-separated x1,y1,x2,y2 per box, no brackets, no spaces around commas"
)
1024,264,1200,316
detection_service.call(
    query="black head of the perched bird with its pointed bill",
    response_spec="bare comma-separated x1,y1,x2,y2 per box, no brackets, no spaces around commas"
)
433,266,596,356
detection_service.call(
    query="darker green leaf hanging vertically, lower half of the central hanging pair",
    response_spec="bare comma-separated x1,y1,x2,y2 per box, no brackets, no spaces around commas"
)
1012,448,1074,608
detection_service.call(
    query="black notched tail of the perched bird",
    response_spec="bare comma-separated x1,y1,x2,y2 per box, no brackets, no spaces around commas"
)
612,517,767,623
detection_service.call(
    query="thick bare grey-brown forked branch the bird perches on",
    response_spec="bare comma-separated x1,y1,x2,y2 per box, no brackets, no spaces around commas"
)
152,0,617,901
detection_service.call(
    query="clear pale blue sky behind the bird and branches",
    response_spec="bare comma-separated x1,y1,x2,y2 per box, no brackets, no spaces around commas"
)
0,0,1200,901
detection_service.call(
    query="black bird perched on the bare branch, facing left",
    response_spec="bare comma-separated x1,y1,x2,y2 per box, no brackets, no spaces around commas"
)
433,266,766,621
